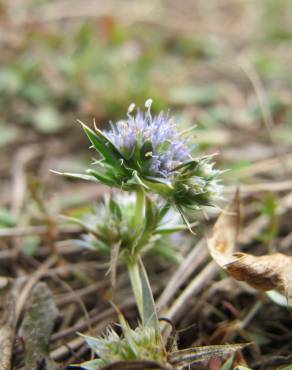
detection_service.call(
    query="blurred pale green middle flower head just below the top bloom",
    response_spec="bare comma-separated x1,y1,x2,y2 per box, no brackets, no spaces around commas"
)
73,193,186,263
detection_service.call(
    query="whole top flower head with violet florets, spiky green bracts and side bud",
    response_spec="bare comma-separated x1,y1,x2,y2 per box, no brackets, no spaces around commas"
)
60,99,222,218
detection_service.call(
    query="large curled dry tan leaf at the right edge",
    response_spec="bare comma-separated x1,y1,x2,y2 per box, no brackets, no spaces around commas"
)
208,192,292,299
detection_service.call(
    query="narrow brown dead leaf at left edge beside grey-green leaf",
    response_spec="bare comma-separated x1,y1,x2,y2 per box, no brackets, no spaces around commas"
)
0,277,16,370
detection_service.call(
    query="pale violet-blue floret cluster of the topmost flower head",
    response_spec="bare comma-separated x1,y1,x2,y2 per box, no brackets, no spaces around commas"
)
105,99,191,178
